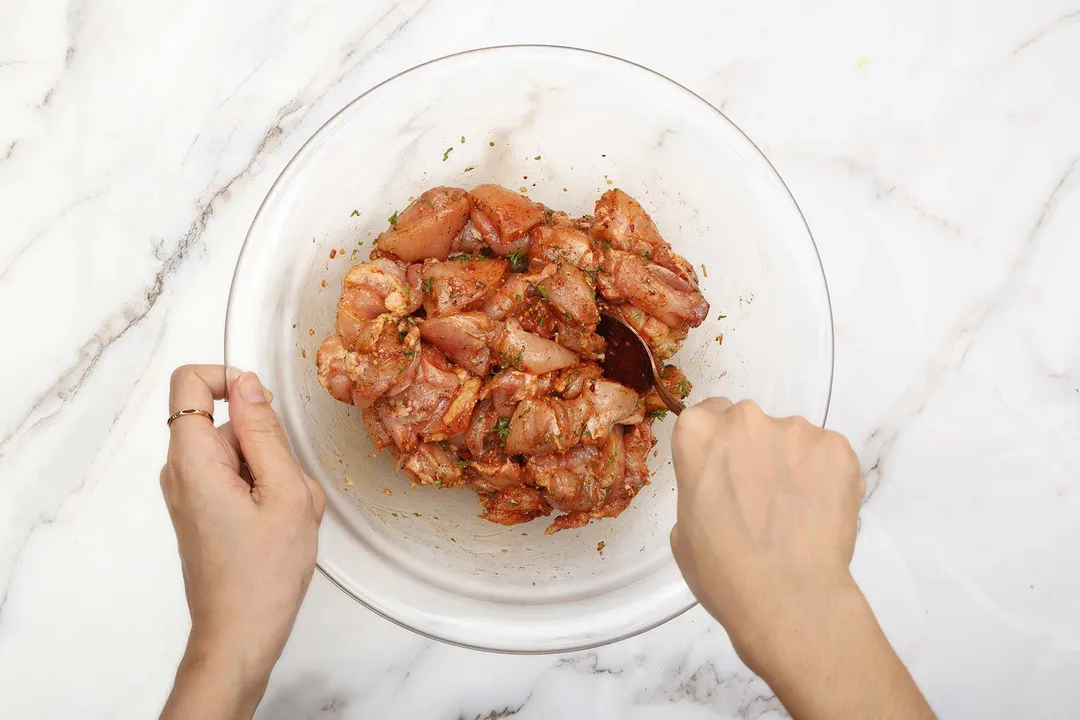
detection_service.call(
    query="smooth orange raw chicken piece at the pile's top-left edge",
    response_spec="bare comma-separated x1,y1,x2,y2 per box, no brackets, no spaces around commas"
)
377,188,472,262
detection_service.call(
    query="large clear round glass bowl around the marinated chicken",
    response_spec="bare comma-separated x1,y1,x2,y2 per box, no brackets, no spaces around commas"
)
225,46,833,652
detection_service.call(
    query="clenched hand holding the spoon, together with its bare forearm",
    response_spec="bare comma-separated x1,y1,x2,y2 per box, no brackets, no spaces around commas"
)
672,398,932,718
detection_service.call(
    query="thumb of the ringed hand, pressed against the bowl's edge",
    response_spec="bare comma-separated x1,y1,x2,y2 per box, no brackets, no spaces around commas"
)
229,372,303,496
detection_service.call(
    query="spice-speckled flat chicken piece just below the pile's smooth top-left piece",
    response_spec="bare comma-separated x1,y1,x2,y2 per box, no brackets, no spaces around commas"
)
423,255,507,317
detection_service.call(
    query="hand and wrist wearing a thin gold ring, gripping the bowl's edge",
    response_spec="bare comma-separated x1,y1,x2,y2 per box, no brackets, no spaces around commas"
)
161,365,326,718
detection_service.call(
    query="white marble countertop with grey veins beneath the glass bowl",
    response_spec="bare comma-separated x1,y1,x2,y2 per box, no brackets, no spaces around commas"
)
0,0,1080,720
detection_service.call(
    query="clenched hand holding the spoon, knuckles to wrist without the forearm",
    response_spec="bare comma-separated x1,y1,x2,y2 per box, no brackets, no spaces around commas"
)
671,398,866,673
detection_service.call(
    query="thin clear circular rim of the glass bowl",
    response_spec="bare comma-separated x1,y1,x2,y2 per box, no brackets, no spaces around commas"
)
224,43,836,655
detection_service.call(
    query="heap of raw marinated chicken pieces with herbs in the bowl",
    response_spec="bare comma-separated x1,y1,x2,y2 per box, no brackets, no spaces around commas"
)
316,185,708,533
